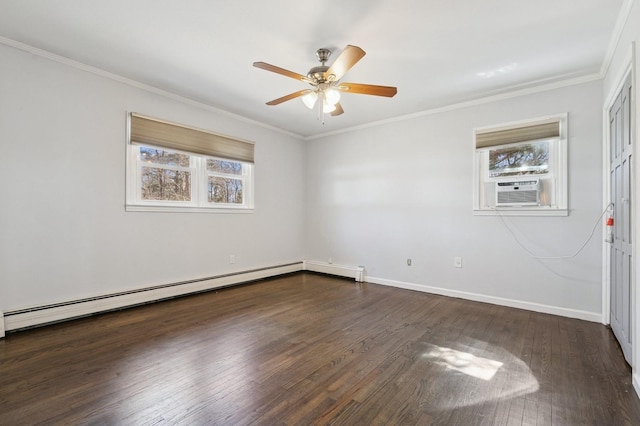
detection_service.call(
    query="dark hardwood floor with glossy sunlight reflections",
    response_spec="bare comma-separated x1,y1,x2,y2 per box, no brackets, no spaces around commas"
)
0,273,640,425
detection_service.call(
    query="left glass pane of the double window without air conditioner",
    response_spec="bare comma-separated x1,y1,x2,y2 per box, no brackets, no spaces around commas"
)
141,167,191,201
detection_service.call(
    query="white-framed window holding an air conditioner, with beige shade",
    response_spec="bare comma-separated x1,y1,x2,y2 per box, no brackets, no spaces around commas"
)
473,114,568,216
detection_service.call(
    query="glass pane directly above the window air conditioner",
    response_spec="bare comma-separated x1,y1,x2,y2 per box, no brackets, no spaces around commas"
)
489,142,549,177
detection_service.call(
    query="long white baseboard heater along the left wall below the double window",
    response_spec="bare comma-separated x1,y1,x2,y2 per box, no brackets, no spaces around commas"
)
0,262,304,337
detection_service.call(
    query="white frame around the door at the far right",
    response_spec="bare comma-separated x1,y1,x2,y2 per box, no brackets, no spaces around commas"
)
602,43,640,371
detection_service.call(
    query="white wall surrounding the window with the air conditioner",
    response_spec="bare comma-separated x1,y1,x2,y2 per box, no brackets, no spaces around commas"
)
307,81,602,320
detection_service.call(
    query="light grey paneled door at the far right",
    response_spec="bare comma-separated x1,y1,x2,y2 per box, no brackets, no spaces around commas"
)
609,75,632,363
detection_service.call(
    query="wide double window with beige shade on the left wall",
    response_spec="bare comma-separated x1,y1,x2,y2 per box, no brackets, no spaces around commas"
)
127,114,253,212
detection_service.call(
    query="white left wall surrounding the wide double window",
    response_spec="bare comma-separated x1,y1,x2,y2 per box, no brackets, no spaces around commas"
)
0,45,305,311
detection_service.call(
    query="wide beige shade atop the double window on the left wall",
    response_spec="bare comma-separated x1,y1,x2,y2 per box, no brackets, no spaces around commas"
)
130,113,254,163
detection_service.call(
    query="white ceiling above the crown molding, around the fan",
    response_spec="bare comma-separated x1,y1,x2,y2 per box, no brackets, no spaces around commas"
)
0,0,625,137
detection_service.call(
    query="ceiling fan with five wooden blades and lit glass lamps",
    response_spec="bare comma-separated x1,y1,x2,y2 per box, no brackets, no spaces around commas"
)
253,45,398,116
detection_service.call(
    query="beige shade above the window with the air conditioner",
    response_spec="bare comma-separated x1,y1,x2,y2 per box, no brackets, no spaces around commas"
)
476,120,560,149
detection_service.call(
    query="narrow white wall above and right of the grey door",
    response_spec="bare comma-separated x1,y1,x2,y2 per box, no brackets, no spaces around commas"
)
604,0,640,394
